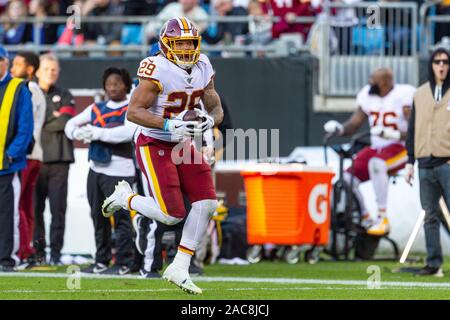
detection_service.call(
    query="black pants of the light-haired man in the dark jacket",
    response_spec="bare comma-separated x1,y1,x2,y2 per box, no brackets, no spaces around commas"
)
34,162,69,261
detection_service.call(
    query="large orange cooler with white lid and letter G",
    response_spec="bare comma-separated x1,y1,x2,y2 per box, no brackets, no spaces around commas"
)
241,164,334,245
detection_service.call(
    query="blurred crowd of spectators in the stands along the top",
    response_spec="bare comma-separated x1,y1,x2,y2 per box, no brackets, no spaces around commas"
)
0,0,450,54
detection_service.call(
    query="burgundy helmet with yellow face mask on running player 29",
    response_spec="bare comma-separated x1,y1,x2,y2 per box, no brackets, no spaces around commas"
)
159,18,201,70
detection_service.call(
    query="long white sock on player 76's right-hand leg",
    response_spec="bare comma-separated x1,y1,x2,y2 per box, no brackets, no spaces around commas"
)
369,158,389,211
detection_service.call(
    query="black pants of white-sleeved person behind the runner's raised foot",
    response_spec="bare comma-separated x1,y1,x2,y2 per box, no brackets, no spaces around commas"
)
87,170,134,266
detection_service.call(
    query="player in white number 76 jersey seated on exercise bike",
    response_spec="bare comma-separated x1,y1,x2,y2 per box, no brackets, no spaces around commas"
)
324,68,415,236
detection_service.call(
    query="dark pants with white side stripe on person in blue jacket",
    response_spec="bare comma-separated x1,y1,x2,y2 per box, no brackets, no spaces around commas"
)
0,173,20,267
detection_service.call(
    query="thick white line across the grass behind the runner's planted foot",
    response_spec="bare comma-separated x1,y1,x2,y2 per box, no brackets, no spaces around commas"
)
0,272,450,290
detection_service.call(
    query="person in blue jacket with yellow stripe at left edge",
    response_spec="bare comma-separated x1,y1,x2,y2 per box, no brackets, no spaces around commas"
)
0,47,33,272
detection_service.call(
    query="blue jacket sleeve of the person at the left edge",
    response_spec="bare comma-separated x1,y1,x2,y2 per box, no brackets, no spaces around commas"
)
6,86,34,159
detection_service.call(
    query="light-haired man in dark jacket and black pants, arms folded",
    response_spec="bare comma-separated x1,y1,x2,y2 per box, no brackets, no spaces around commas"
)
34,54,75,265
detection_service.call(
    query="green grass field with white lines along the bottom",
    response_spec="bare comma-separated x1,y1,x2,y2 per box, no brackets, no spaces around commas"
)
0,261,450,300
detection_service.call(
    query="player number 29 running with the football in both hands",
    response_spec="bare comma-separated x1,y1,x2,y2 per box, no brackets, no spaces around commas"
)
103,17,223,294
